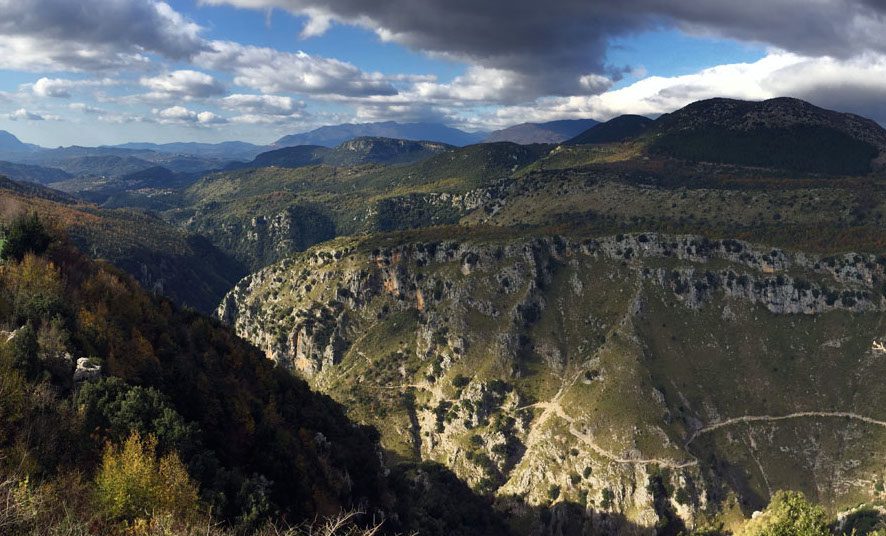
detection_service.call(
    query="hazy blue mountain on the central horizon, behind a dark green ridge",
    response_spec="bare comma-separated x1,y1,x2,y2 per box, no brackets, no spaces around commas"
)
273,121,487,147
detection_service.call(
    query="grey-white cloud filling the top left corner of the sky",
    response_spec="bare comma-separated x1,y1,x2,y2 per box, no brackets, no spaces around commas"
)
0,0,206,71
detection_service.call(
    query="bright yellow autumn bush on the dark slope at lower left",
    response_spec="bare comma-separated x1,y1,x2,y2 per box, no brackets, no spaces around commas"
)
95,432,198,521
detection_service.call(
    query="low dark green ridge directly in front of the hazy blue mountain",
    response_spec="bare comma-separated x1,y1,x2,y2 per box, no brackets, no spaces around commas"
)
241,137,452,169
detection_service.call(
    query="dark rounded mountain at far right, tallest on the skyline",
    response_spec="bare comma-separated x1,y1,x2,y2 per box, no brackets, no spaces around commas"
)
648,98,886,175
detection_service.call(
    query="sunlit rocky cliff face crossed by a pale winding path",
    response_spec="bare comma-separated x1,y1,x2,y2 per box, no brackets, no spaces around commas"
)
218,234,886,527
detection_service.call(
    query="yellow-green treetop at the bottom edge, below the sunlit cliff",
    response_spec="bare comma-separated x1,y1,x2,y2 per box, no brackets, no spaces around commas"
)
735,491,830,536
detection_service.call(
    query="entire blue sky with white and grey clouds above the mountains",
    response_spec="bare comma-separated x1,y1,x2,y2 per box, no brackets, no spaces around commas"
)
0,0,886,147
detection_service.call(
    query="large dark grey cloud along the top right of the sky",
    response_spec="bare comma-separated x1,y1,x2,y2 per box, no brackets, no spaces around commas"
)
202,0,886,100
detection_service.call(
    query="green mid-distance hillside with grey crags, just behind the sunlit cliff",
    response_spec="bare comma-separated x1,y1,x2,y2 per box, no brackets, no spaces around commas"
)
165,140,550,269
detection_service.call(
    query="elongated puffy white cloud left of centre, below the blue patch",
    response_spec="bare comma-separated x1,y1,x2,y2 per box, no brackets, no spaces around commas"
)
194,41,397,96
